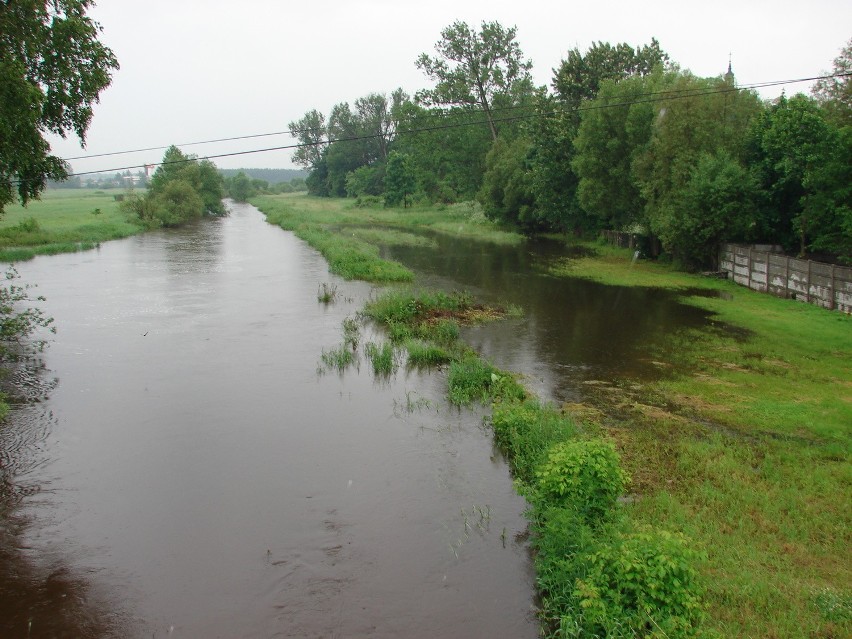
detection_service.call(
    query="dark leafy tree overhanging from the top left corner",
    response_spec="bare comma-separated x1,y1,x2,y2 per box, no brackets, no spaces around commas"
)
0,0,118,213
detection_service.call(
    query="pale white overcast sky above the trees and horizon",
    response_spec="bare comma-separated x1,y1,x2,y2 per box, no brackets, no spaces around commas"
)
52,0,852,172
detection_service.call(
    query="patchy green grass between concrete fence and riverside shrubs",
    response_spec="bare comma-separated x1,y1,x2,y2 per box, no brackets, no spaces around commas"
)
554,242,852,637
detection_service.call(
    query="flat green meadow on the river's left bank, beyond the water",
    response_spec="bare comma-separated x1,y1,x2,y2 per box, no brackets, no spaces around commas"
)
0,189,142,262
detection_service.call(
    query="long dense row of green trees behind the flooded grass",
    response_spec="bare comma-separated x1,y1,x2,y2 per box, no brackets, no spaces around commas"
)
289,22,852,268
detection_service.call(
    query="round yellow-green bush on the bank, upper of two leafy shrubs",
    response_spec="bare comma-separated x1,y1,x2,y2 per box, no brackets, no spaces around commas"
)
535,439,627,522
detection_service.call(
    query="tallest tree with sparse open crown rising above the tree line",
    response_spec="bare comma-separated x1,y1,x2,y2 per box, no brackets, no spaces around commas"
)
416,22,532,140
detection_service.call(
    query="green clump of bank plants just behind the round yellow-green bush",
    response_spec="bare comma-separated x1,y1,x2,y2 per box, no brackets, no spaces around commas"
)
491,401,576,484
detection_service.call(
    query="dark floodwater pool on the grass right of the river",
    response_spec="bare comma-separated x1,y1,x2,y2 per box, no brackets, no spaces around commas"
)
385,235,720,402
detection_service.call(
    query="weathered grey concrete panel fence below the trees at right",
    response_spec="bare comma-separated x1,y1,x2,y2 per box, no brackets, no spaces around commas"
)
719,244,852,313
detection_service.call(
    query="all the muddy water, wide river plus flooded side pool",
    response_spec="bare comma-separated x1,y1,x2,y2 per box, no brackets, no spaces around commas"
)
0,205,720,638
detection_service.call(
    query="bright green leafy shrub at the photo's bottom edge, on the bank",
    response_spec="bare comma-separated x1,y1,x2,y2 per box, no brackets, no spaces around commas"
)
572,529,704,637
